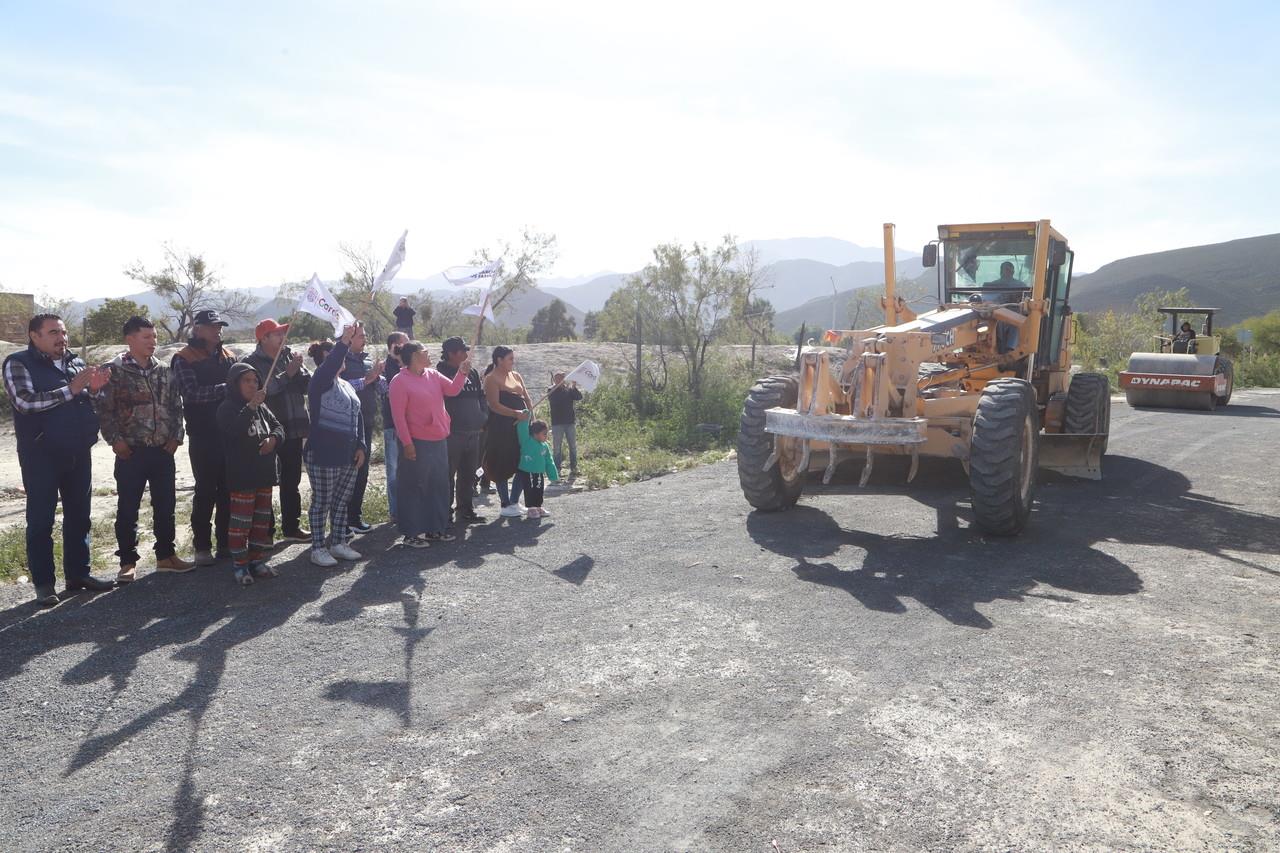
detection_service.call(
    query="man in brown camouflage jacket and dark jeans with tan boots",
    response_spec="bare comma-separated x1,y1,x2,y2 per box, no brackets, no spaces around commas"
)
96,316,195,584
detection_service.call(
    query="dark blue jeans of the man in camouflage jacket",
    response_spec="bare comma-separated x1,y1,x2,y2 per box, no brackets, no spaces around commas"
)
115,447,178,566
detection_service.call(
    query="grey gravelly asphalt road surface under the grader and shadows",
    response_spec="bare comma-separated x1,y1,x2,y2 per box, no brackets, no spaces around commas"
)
0,392,1280,852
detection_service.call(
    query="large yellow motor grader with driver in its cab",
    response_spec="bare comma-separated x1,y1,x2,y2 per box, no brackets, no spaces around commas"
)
737,219,1111,535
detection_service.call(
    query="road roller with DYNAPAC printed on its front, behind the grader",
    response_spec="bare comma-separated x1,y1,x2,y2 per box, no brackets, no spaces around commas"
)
1120,307,1235,411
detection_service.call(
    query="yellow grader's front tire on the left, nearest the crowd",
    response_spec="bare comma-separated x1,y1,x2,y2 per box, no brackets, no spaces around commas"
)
737,375,804,512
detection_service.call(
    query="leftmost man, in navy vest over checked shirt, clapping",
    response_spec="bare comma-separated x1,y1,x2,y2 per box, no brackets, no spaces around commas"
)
3,314,114,607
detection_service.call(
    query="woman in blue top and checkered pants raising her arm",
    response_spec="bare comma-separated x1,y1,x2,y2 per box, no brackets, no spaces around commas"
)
302,323,369,566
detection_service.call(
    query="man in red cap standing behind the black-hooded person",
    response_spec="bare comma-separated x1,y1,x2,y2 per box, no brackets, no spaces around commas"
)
243,318,311,542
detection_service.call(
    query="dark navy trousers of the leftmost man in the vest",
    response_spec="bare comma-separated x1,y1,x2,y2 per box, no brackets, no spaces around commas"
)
18,447,93,587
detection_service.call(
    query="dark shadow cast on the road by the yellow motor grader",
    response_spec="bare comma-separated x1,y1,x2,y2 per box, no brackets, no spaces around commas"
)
748,456,1280,629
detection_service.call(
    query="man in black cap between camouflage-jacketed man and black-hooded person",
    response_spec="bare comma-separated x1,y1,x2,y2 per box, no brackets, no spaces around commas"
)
172,309,236,566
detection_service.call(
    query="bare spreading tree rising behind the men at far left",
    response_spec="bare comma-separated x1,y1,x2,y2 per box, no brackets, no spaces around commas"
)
124,243,253,341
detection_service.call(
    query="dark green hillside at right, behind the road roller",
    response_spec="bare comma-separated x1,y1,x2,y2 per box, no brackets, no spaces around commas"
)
1071,234,1280,327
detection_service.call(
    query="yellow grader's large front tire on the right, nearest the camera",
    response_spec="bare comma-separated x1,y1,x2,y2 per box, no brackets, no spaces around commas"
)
969,379,1039,537
